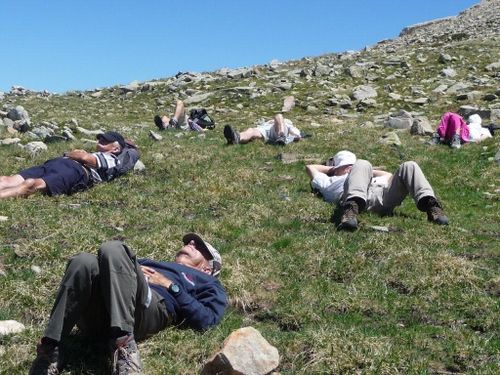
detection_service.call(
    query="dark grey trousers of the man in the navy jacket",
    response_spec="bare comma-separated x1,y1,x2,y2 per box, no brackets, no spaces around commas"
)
44,241,171,341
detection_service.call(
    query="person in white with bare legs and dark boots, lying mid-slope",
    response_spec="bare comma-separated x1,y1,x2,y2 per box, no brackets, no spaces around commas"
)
224,114,302,146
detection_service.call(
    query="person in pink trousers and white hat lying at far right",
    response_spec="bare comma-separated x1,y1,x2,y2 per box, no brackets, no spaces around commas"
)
429,112,492,148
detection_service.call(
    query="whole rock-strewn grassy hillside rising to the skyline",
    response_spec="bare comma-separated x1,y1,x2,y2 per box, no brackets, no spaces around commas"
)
0,0,500,375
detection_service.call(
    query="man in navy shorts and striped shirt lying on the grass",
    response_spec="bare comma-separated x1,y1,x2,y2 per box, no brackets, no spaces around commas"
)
0,131,139,198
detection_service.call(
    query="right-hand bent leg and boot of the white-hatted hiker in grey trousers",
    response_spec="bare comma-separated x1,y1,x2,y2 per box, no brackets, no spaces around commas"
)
382,161,448,224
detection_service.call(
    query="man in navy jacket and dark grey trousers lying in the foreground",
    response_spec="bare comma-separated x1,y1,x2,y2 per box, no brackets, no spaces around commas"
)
29,233,227,375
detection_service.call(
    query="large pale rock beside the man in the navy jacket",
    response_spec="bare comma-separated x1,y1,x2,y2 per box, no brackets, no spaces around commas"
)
201,327,279,375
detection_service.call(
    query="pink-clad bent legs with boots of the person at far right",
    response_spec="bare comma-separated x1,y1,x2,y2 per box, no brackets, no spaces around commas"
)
430,112,470,148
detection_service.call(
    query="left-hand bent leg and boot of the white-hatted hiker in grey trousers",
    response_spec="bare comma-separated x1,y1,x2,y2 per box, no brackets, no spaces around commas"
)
339,160,373,230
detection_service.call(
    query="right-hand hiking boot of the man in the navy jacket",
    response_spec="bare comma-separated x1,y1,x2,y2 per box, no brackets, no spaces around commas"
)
112,335,142,375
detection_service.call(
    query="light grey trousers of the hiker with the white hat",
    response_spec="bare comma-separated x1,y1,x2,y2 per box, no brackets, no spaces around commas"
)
342,160,435,214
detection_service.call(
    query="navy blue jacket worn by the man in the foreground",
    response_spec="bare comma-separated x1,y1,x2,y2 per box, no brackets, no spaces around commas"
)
138,259,227,330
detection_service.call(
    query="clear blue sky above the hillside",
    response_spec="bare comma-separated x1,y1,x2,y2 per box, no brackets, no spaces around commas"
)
0,0,479,92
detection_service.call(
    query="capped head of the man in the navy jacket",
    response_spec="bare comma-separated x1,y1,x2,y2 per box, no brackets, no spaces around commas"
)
175,233,222,276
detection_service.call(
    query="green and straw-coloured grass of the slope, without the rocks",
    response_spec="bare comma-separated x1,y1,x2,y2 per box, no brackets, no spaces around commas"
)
0,36,500,374
